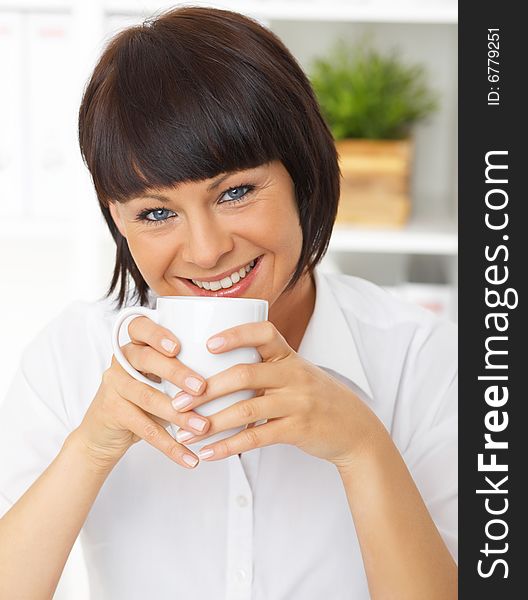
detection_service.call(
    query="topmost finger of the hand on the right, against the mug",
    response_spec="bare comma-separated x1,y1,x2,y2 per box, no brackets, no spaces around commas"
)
206,321,295,361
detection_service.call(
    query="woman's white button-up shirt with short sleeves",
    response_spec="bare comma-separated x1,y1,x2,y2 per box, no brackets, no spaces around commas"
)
0,269,457,600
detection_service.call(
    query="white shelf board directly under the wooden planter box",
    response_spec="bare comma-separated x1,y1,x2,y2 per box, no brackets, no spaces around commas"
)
329,222,458,256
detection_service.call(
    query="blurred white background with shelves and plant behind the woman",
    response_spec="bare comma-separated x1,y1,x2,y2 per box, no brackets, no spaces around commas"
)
0,0,458,600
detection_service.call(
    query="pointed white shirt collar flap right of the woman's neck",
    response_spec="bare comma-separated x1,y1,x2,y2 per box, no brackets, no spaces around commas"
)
298,267,372,398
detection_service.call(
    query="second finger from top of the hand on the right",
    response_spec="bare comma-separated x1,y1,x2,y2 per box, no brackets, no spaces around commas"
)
174,363,288,411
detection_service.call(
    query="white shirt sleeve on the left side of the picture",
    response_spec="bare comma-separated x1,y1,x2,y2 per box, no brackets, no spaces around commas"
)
0,331,71,516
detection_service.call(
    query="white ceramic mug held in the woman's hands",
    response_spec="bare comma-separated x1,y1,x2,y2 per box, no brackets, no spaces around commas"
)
112,296,268,451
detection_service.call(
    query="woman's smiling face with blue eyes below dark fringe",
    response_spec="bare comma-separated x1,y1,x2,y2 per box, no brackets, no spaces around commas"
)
110,161,302,307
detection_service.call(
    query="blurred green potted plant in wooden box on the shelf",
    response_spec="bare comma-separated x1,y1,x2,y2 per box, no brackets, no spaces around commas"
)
310,39,438,226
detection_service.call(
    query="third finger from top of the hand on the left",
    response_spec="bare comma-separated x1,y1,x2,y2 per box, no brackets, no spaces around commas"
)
114,360,210,434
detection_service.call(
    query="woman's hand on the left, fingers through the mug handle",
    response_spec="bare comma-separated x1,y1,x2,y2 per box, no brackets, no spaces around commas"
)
74,316,210,468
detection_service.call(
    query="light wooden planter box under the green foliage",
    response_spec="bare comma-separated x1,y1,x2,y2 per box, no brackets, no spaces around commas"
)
336,139,412,227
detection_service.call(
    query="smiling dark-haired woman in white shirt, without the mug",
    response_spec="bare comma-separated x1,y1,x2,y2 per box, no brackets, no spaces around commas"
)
0,8,456,600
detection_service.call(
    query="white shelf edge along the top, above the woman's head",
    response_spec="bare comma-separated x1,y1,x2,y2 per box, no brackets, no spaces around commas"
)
104,0,458,24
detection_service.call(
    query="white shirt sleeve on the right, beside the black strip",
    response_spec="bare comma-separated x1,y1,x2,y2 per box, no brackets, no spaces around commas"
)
393,320,458,560
